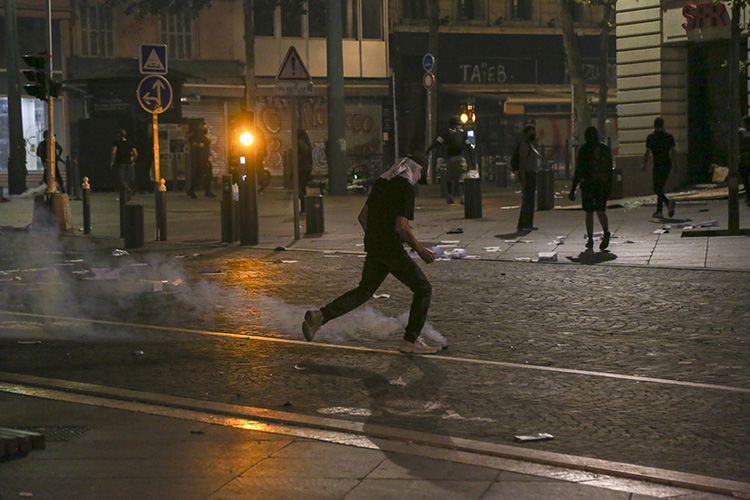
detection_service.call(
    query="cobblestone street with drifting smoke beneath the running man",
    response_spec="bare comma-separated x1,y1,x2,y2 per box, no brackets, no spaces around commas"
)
0,238,750,481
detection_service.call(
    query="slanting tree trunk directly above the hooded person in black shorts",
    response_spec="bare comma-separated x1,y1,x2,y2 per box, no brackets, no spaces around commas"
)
557,0,591,144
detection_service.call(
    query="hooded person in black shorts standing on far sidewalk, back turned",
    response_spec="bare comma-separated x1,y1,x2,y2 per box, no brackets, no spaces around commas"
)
568,127,612,250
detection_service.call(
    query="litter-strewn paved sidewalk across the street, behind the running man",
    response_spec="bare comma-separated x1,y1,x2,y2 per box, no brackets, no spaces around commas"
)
0,181,750,270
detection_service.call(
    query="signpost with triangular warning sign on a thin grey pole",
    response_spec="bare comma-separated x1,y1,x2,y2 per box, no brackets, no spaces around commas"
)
274,45,313,241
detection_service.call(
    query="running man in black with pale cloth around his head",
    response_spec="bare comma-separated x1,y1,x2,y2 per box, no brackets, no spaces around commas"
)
302,155,436,354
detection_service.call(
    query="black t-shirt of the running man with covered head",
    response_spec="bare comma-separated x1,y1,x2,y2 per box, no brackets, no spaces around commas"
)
365,176,414,256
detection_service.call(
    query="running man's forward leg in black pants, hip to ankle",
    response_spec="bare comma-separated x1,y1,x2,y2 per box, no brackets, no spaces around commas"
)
387,253,432,342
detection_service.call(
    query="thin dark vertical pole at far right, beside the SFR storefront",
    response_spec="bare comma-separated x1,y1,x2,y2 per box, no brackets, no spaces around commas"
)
727,0,741,234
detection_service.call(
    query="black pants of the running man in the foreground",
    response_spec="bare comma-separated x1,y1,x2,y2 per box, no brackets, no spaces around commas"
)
321,252,432,342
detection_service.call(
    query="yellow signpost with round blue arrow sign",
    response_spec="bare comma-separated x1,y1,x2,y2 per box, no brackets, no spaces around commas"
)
136,71,173,241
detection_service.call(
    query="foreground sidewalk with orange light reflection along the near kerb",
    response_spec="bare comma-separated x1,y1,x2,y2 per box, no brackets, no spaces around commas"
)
0,384,747,500
